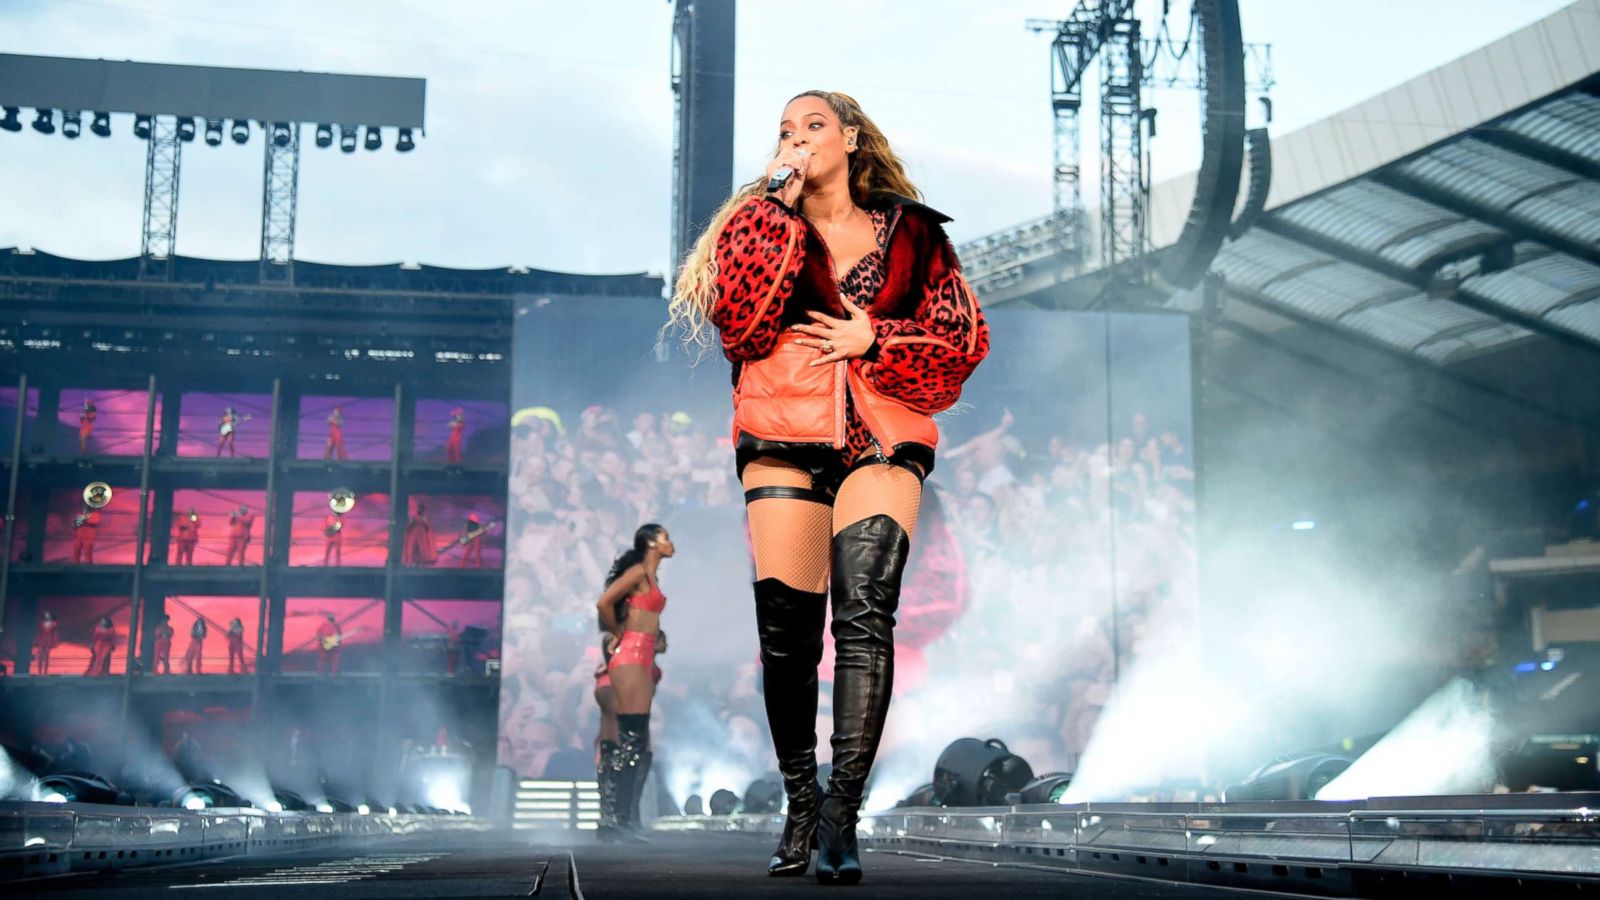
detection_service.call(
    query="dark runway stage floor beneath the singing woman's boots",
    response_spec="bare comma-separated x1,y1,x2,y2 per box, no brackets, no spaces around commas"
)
6,833,1259,900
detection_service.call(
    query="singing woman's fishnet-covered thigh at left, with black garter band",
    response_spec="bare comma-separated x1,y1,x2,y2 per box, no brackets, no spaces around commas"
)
744,456,832,594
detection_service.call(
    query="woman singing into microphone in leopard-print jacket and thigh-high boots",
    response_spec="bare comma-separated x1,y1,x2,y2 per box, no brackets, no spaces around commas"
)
670,91,989,884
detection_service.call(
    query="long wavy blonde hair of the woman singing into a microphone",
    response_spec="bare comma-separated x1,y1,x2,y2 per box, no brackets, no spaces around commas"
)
664,91,922,349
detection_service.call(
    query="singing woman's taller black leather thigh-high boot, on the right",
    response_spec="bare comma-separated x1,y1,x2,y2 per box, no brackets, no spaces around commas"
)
816,516,910,884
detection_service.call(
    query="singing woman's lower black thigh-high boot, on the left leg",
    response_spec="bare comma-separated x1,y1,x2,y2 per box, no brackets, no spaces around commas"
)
755,578,824,876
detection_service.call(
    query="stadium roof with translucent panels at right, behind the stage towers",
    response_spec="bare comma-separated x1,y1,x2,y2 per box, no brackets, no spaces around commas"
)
963,0,1600,415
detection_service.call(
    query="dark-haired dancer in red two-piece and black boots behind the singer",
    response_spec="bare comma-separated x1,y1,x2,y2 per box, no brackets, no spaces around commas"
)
595,524,675,842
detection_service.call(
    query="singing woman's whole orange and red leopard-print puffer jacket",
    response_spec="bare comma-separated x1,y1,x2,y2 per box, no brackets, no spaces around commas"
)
710,195,989,455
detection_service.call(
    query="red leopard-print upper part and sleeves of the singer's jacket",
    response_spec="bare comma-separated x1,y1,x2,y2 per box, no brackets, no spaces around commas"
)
710,197,989,415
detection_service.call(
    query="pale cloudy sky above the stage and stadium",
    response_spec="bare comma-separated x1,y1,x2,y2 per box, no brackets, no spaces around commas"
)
0,0,1566,274
